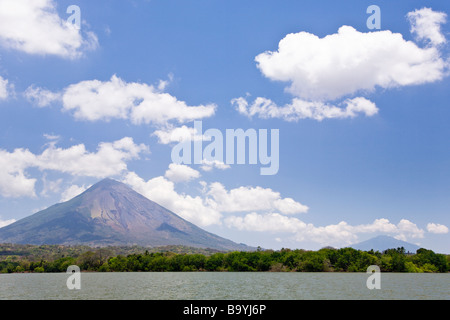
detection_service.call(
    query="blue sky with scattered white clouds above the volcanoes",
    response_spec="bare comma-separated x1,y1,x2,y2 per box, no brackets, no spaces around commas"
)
0,0,450,253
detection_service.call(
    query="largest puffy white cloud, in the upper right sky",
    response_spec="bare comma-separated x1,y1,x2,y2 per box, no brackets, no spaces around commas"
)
255,26,447,101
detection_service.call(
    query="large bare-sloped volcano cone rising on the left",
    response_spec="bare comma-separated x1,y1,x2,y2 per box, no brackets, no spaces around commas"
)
0,179,249,250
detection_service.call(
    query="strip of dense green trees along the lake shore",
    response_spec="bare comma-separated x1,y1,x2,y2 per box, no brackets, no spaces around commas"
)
0,244,450,273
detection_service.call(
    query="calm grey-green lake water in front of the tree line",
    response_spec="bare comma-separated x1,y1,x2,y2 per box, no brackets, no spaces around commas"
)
0,272,450,300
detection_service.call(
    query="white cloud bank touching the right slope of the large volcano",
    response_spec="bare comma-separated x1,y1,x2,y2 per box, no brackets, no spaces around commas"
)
123,168,308,226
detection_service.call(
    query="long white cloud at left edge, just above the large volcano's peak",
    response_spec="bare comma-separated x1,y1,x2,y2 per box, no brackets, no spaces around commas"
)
0,137,148,197
